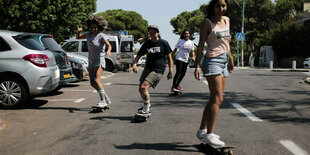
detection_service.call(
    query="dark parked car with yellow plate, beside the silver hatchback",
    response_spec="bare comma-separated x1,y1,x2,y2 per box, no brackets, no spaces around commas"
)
29,33,72,89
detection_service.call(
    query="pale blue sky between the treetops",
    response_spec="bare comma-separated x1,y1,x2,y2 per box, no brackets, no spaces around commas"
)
95,0,209,49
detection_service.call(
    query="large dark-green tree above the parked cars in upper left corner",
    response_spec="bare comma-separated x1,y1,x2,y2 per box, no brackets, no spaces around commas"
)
0,0,96,41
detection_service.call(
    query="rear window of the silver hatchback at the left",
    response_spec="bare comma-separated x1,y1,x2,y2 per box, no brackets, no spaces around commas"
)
13,35,45,50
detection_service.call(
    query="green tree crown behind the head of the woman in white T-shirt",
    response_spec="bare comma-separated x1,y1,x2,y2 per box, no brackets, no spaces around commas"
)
170,9,204,39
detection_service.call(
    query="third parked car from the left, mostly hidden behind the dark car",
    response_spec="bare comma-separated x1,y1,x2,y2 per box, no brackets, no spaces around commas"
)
69,57,85,82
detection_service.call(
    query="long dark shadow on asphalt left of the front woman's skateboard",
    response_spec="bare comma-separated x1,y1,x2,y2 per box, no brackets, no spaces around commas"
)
115,142,199,152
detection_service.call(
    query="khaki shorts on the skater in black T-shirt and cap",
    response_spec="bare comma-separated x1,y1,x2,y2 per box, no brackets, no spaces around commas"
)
139,68,163,88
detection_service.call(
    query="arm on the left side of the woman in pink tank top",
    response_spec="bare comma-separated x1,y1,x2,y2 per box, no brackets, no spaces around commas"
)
195,20,211,80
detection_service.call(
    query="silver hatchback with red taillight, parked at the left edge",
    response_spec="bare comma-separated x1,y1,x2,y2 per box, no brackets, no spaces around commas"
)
0,30,60,108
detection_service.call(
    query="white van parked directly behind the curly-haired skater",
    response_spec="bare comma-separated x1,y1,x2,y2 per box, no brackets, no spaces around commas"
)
62,36,120,72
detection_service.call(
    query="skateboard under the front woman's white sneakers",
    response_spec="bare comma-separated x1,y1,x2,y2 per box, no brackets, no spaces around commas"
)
200,143,235,155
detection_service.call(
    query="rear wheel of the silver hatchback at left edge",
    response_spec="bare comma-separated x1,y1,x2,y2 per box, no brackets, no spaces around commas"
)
0,77,29,108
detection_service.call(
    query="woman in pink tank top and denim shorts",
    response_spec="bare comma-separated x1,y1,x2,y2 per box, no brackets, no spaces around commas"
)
195,0,234,146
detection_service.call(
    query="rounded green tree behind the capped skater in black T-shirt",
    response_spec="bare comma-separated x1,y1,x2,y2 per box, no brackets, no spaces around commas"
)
97,9,148,41
